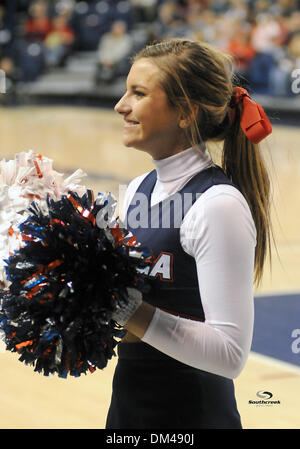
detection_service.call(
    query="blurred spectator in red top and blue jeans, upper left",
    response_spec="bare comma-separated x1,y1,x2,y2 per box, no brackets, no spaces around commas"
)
44,14,75,67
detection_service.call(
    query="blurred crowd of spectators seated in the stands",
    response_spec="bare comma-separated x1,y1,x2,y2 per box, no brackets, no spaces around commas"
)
0,0,300,104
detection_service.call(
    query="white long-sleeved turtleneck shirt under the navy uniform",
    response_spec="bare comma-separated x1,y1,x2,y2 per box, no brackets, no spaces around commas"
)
124,148,256,378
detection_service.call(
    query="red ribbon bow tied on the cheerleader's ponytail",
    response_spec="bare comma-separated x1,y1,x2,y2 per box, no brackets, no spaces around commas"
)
233,87,272,143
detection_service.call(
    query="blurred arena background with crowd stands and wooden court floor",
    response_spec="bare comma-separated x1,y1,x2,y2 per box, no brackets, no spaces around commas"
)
0,0,300,429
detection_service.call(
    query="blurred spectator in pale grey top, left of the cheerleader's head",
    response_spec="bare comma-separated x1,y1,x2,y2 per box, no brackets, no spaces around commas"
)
95,20,133,84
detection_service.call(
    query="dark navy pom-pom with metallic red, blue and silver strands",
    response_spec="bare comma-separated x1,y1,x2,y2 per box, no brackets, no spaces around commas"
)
0,191,147,377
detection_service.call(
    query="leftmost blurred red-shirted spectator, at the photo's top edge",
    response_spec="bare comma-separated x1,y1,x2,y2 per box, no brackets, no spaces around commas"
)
25,0,51,41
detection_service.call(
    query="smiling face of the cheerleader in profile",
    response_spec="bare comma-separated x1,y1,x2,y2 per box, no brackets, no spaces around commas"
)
115,58,189,159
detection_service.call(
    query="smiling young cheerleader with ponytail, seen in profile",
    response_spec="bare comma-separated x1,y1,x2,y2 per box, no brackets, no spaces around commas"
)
106,39,271,429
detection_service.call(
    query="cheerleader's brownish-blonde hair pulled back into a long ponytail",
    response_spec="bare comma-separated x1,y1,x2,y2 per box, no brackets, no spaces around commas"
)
133,39,271,284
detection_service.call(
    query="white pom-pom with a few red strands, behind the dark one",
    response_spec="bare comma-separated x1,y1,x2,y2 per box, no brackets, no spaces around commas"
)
0,150,86,288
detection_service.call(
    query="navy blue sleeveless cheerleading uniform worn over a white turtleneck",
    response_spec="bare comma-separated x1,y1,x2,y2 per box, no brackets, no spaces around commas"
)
106,166,242,429
